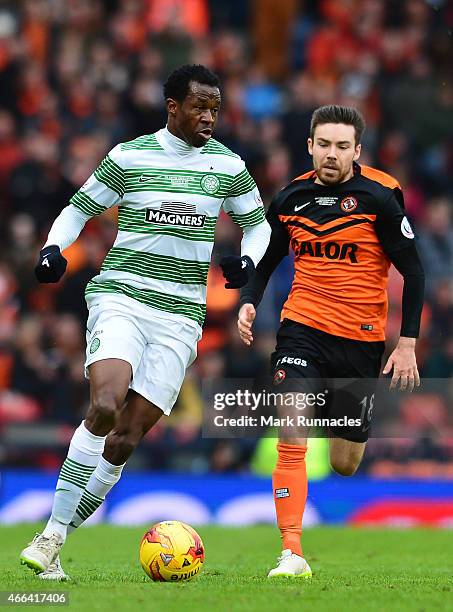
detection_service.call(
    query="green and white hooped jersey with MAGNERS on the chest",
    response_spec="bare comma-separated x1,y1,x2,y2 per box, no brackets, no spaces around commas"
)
71,128,265,326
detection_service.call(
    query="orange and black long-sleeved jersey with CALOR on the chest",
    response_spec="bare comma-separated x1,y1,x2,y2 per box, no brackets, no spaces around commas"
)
241,164,424,341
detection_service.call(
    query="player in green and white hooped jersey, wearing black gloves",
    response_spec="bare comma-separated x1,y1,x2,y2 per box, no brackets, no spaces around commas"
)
20,65,271,580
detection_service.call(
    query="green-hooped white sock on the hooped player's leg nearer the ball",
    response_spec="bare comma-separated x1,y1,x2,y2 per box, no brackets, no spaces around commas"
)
68,457,126,533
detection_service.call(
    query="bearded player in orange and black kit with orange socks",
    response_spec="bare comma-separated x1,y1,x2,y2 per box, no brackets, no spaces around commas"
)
238,105,424,577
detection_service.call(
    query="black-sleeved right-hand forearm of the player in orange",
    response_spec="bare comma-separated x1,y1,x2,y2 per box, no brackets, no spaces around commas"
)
391,245,425,340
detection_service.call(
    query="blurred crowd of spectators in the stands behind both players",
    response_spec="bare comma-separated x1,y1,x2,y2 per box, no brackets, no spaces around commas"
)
0,0,453,477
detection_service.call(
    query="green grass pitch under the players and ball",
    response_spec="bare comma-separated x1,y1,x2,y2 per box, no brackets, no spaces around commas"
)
0,525,453,612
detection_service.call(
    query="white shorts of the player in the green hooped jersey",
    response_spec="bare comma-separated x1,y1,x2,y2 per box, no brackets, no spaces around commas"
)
85,294,201,415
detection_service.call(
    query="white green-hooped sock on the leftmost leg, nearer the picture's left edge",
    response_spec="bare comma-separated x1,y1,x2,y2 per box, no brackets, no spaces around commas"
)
43,421,106,540
